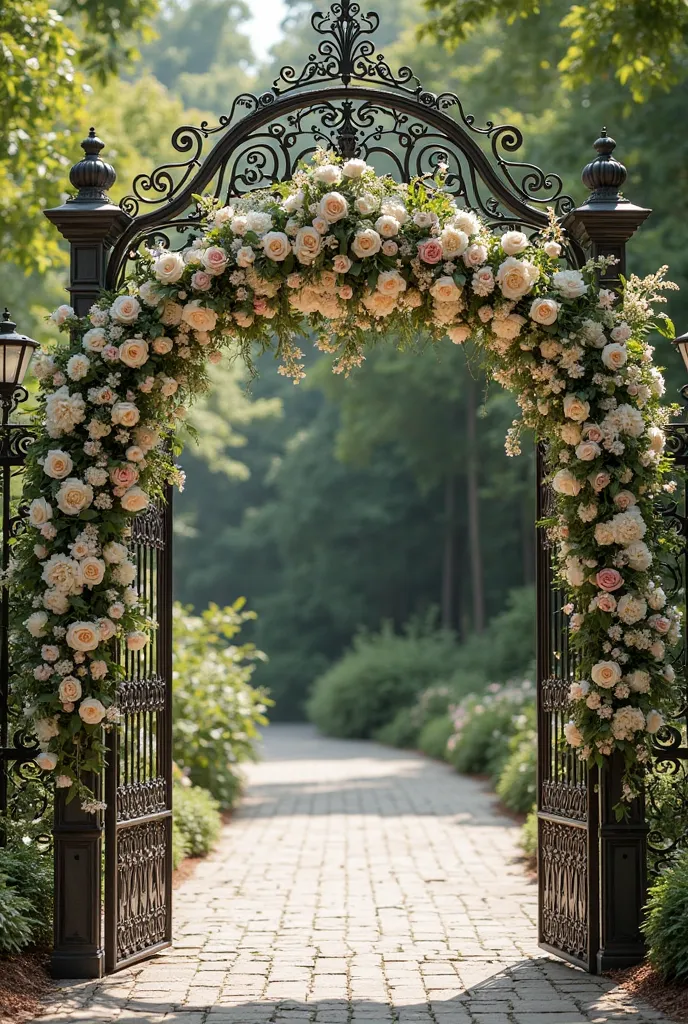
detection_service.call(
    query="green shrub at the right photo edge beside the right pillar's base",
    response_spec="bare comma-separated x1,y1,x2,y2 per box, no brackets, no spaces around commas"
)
643,850,688,983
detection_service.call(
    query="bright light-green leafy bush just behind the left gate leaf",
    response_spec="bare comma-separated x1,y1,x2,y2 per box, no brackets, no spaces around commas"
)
172,600,271,808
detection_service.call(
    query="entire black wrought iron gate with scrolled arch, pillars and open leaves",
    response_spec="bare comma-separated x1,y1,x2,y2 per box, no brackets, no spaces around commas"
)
41,0,649,977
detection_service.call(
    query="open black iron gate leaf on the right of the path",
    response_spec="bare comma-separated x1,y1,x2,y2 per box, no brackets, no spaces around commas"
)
536,444,599,973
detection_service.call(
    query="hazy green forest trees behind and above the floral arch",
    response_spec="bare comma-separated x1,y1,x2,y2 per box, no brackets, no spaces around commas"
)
5,0,688,719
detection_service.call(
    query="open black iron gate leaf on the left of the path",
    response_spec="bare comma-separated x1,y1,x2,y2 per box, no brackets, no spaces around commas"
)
105,488,172,971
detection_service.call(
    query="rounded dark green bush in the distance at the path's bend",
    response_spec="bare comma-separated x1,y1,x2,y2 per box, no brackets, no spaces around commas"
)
308,624,457,738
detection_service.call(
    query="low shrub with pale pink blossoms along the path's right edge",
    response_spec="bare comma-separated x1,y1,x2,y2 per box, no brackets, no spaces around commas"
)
447,680,534,777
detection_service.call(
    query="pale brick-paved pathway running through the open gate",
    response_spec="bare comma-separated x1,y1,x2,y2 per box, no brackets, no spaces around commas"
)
32,726,665,1024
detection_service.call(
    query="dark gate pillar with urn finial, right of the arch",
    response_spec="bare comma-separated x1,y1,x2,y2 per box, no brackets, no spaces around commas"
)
564,128,651,972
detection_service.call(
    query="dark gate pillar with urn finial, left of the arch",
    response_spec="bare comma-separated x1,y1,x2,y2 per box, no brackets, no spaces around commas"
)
45,128,130,978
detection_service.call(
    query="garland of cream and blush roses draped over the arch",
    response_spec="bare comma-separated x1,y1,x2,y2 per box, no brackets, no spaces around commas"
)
9,152,680,810
